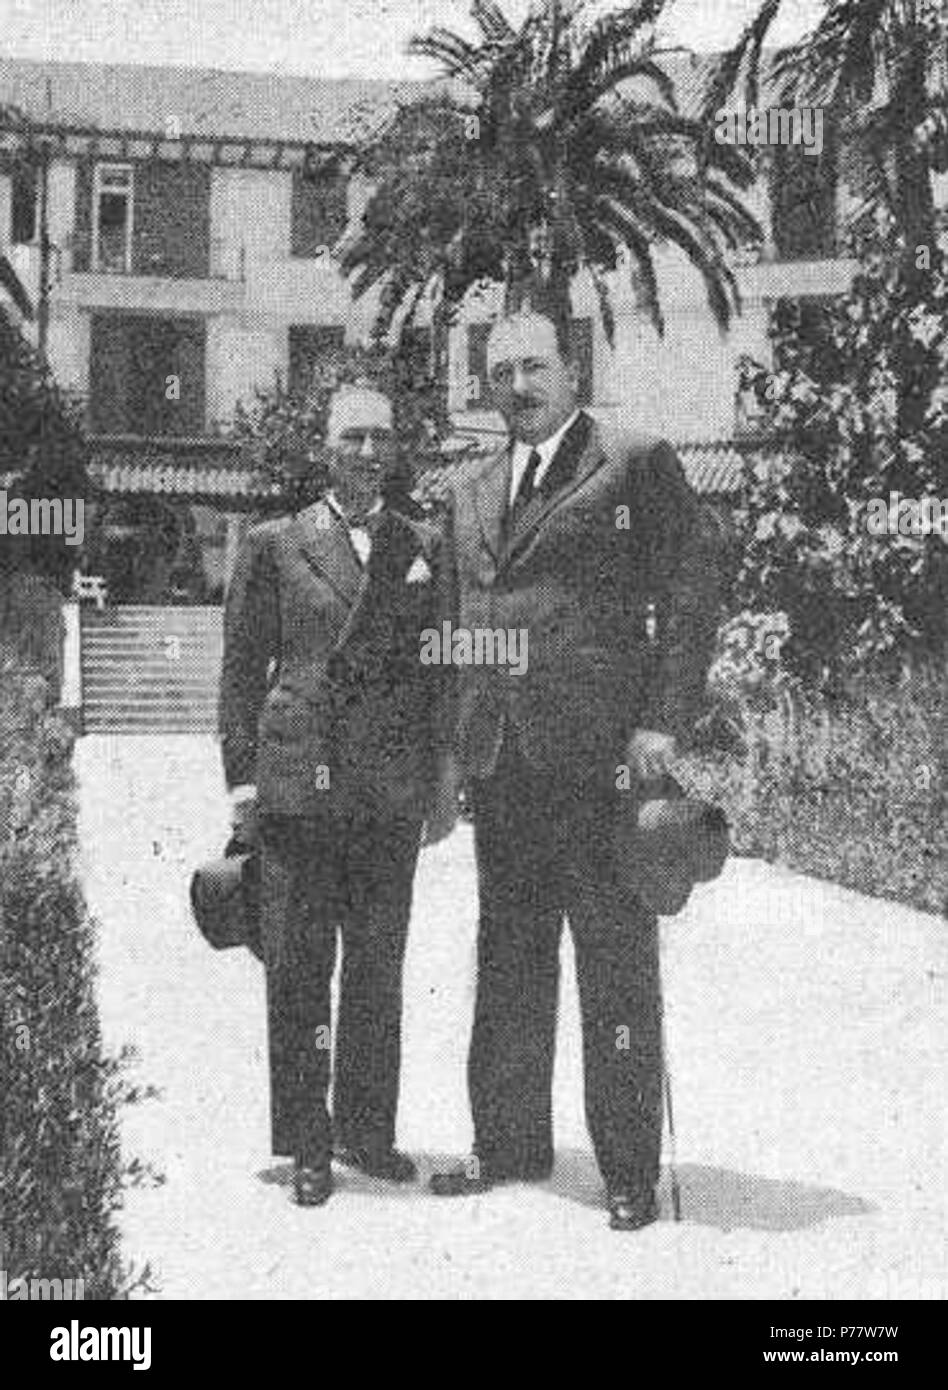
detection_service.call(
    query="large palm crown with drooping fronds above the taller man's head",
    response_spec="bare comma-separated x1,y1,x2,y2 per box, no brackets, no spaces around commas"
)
342,0,762,369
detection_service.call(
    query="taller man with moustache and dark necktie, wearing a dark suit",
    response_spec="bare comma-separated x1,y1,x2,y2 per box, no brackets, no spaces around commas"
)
432,313,713,1230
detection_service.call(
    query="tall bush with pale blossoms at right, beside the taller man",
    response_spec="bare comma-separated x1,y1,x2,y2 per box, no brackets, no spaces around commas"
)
738,237,948,682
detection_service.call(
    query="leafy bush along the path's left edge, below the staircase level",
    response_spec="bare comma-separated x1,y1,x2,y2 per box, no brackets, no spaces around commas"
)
0,648,128,1298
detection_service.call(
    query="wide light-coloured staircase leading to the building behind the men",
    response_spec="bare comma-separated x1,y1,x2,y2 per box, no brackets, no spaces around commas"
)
82,605,222,734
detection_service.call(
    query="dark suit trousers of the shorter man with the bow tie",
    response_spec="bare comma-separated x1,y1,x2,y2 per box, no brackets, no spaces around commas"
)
260,809,421,1158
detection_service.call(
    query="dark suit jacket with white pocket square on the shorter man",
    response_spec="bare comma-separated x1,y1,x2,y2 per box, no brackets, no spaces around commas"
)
218,502,436,816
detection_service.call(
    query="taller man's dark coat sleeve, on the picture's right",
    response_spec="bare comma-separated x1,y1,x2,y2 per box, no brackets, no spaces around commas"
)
639,442,721,741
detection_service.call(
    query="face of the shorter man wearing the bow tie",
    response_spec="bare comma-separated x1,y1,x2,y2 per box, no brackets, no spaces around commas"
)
325,386,395,518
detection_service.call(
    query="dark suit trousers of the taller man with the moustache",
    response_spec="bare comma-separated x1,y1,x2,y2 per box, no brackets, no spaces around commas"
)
468,734,662,1188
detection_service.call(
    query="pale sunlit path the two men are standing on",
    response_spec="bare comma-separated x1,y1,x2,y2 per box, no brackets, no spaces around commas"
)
76,737,948,1300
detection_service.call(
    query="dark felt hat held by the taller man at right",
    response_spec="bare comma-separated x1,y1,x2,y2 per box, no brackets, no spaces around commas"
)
616,777,728,917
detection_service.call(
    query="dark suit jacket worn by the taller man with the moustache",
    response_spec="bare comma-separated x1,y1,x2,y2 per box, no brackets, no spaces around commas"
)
445,414,717,781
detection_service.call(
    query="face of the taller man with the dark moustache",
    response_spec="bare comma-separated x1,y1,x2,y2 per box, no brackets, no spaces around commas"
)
487,314,578,445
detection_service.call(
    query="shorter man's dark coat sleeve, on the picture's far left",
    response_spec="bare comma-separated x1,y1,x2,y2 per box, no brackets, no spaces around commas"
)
218,531,279,790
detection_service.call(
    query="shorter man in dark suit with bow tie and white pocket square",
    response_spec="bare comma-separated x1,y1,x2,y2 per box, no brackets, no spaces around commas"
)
220,386,444,1205
